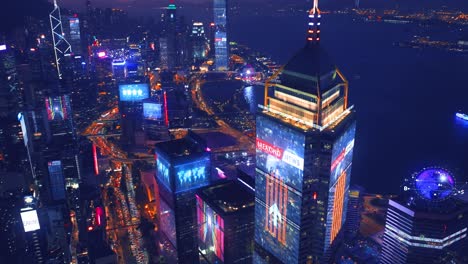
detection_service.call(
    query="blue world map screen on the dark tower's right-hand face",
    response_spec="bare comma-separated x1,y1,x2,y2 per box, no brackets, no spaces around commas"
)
174,157,210,192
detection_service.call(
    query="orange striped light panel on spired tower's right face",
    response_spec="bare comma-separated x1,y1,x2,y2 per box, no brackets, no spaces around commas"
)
330,171,346,244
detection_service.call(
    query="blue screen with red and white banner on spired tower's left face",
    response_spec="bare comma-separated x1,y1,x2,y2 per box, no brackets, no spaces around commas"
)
256,116,305,191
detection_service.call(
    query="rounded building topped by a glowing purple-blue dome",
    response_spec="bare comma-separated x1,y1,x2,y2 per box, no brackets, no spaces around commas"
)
380,168,468,264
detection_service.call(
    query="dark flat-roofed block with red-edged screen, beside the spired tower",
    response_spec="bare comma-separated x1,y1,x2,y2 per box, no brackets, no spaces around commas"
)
197,181,255,264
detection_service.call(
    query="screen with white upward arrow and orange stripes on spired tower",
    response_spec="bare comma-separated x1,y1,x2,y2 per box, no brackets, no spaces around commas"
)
255,170,301,263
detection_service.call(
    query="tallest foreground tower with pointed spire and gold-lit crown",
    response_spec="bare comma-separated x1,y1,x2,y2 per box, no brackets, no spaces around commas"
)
254,1,356,263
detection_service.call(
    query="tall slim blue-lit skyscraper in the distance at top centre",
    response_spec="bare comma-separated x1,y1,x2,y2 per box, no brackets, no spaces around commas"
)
213,0,229,71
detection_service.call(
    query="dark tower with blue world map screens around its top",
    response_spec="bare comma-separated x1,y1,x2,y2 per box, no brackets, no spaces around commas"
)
155,132,211,263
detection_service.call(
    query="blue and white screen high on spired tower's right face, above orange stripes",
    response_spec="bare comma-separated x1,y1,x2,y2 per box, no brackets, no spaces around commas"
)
330,123,356,187
